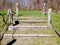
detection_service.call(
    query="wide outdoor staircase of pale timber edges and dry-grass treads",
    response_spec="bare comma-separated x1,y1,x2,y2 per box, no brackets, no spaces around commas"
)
2,17,56,45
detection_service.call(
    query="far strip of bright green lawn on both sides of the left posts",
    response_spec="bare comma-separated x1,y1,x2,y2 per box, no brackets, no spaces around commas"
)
0,11,42,17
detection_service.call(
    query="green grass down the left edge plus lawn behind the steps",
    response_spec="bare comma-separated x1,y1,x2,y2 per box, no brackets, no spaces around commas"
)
0,11,46,30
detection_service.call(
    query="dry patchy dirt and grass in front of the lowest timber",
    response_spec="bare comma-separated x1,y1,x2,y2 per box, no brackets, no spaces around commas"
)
1,37,60,45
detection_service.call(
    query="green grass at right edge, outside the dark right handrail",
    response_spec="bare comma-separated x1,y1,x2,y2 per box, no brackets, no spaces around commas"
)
51,14,60,32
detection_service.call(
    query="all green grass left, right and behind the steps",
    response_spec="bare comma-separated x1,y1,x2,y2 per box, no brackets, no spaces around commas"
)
0,11,60,32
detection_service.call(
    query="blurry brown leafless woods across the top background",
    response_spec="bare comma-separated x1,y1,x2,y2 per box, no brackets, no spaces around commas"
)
0,0,60,12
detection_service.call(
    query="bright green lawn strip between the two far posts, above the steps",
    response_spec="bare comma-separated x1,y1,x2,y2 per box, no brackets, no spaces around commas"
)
19,11,42,16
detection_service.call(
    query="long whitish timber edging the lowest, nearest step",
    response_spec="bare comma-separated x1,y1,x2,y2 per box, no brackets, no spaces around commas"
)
4,34,56,37
